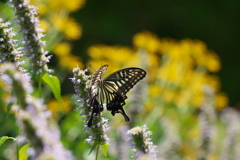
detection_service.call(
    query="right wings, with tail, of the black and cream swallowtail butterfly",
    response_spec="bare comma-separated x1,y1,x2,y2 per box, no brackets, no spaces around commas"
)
103,68,146,122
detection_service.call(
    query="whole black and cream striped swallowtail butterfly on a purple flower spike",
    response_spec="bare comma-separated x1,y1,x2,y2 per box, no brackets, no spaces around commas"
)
87,65,147,127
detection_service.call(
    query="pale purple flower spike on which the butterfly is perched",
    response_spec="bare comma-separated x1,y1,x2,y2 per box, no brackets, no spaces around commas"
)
71,67,109,145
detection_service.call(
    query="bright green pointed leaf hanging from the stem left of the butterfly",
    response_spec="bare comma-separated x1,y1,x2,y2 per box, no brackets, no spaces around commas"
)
42,73,63,105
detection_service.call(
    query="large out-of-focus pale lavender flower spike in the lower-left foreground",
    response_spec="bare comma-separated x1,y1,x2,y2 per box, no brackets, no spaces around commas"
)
1,63,73,159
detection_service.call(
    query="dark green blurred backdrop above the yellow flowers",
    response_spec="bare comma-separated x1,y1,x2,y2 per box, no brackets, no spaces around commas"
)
73,0,240,106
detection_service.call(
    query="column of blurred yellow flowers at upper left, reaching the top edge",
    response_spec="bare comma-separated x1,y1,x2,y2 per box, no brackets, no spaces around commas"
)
31,0,85,71
